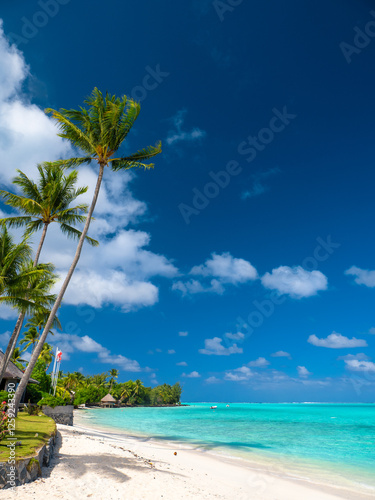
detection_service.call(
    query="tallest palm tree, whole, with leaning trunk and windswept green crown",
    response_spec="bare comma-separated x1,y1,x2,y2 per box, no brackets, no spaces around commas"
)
14,88,161,411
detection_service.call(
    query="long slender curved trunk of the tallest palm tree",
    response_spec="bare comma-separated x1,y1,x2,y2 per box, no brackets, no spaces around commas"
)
14,163,105,415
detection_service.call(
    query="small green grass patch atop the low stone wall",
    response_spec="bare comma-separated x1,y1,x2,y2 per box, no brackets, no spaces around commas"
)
0,413,56,462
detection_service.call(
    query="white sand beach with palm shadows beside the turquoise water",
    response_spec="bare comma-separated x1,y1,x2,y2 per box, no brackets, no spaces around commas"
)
1,425,370,500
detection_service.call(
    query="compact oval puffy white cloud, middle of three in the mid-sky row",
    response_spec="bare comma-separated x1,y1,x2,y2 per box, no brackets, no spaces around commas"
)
261,266,328,299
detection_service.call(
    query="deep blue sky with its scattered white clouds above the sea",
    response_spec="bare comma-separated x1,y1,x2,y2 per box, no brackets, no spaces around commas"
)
0,0,375,401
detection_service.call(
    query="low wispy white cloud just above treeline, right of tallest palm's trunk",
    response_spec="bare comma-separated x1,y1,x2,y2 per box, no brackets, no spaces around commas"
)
48,332,141,372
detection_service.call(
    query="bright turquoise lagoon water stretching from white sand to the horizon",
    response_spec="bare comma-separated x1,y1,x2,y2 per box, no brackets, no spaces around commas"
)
77,403,375,488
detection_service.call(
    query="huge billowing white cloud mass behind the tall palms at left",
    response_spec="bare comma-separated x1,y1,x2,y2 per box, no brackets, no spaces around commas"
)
0,28,177,312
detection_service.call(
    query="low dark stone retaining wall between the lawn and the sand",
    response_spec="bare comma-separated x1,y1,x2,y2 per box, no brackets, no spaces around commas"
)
0,434,56,490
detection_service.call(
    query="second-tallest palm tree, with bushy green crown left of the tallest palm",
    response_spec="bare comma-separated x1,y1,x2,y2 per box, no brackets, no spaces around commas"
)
0,163,98,382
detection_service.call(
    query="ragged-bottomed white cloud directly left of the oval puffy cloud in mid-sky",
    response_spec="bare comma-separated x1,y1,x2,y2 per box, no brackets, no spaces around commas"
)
172,252,258,295
